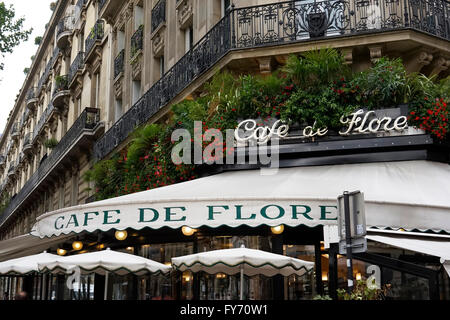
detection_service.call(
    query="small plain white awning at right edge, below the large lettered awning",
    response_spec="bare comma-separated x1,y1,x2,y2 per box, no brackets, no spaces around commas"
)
366,234,450,276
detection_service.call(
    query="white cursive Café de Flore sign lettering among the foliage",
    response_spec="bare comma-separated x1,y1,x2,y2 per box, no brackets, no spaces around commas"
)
234,109,408,144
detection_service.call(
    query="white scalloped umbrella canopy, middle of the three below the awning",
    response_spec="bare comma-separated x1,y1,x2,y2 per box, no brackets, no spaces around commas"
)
39,248,172,275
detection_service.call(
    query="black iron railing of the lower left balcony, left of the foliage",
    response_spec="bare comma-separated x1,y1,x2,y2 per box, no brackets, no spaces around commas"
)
0,108,100,225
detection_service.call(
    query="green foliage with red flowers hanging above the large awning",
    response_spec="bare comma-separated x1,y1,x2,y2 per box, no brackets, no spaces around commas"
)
86,49,449,200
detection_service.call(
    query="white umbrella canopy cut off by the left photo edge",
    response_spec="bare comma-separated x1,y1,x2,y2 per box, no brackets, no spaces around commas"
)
0,251,60,275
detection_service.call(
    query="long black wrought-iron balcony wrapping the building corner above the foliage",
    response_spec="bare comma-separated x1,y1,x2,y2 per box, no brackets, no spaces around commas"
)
94,0,450,159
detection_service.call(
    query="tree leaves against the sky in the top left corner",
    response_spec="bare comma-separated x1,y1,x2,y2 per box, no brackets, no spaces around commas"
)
0,2,33,70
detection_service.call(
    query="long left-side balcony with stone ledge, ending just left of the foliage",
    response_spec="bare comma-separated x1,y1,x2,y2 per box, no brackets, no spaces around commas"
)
0,108,104,225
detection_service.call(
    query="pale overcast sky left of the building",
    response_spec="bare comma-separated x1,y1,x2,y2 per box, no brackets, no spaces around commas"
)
0,0,53,133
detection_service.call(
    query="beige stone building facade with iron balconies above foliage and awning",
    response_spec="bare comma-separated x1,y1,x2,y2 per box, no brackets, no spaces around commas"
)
0,0,450,240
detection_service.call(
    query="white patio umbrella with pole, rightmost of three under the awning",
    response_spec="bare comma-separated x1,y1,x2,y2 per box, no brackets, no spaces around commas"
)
172,246,314,300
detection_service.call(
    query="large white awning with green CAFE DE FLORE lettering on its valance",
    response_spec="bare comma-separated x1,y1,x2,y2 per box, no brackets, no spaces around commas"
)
33,161,450,237
